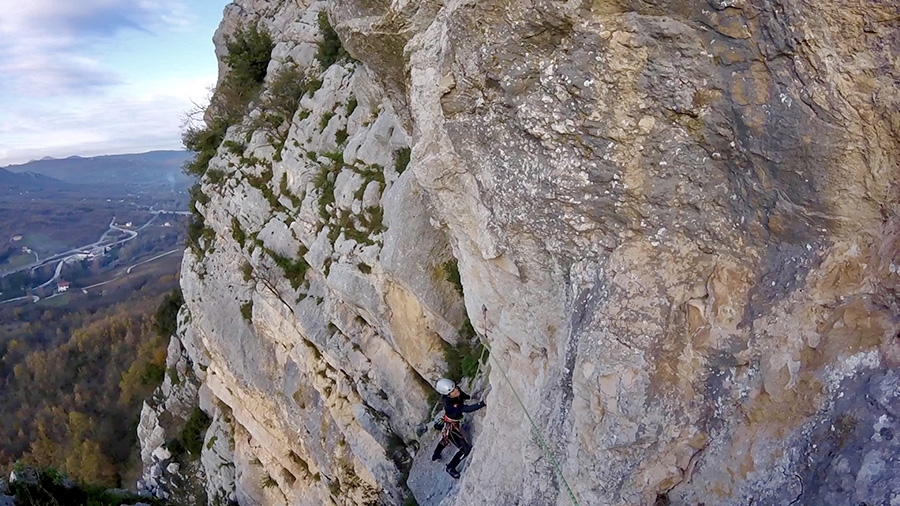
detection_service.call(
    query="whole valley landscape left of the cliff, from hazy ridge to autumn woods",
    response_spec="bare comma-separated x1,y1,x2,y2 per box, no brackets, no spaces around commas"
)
0,152,191,487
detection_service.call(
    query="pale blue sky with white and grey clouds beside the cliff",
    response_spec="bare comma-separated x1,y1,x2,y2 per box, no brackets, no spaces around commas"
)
0,0,229,167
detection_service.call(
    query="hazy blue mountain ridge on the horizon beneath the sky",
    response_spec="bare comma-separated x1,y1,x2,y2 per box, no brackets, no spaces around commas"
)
3,151,192,186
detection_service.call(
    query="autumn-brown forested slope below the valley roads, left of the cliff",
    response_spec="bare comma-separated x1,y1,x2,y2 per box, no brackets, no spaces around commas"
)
0,275,181,487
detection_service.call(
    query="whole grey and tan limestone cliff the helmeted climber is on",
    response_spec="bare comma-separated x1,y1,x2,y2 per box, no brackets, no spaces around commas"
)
141,0,900,505
